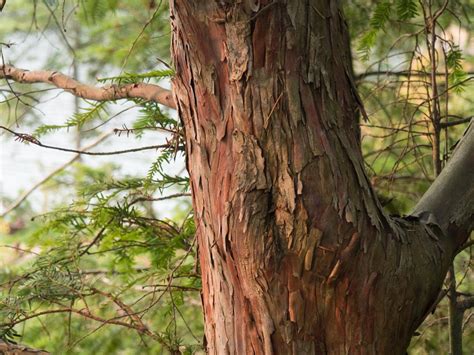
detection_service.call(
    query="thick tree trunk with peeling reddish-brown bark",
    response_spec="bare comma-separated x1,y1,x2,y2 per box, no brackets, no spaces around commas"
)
171,0,473,354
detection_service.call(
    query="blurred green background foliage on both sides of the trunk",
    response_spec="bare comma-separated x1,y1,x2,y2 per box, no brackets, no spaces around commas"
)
0,0,474,354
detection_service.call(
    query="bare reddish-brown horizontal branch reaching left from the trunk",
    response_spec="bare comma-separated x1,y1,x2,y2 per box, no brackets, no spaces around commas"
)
0,65,176,109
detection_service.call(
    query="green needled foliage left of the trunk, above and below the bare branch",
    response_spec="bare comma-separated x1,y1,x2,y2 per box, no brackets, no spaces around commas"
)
0,0,199,353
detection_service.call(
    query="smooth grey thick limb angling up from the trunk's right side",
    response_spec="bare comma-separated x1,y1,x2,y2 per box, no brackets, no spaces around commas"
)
411,123,474,249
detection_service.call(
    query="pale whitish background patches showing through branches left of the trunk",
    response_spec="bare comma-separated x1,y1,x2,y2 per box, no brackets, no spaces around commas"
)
0,35,184,217
